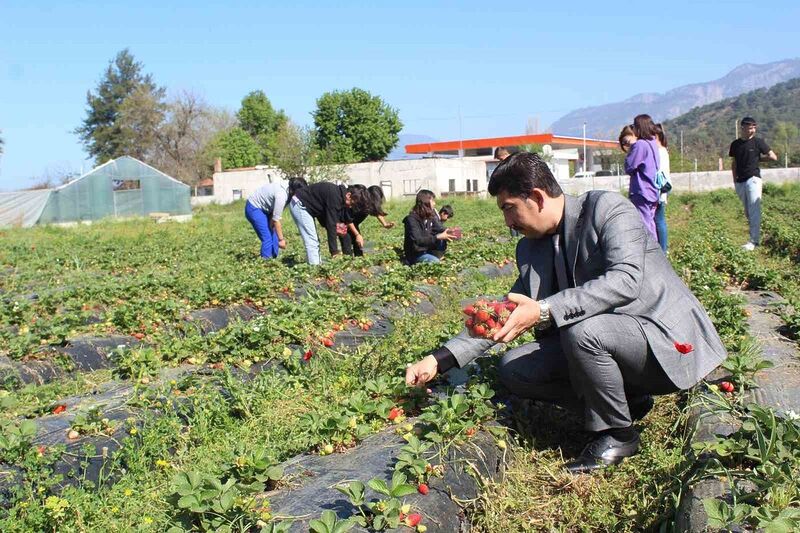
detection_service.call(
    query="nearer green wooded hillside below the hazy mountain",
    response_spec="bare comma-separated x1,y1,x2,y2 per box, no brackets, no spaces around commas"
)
664,77,800,166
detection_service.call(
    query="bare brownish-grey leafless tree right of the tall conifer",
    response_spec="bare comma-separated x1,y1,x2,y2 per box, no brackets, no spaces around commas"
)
149,91,236,185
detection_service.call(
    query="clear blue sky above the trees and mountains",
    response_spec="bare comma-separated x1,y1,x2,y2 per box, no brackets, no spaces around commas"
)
0,0,800,190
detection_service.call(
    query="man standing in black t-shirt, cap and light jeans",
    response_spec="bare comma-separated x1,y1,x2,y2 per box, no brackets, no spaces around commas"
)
728,117,778,251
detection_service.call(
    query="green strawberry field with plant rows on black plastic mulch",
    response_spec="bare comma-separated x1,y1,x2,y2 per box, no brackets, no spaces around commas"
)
0,187,800,532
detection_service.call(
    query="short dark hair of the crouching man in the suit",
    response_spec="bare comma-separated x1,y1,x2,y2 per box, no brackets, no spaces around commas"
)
489,152,564,198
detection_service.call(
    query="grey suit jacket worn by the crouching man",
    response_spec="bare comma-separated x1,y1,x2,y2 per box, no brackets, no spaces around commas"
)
445,191,726,389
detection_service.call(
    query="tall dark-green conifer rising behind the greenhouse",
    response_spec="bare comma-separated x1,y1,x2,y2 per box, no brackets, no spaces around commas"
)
75,48,164,163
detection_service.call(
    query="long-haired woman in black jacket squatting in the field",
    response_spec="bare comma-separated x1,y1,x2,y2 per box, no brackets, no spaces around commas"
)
403,189,453,265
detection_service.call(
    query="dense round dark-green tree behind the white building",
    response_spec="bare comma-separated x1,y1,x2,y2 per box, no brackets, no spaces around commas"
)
312,88,403,163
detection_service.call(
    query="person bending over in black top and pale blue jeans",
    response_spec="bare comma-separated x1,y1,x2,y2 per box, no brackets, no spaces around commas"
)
289,181,366,265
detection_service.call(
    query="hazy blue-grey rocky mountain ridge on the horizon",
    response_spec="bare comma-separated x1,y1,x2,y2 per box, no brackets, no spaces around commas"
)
550,59,800,139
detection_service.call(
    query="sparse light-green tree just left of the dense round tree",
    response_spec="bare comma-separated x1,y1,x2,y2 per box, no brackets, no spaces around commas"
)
272,121,345,183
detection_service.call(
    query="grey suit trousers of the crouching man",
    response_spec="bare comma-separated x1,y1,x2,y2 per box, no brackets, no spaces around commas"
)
499,314,678,431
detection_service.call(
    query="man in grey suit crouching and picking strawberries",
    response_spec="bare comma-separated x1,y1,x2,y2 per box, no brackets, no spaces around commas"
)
406,153,726,473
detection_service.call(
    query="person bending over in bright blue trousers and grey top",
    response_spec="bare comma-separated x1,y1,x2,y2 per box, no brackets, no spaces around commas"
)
244,178,305,259
